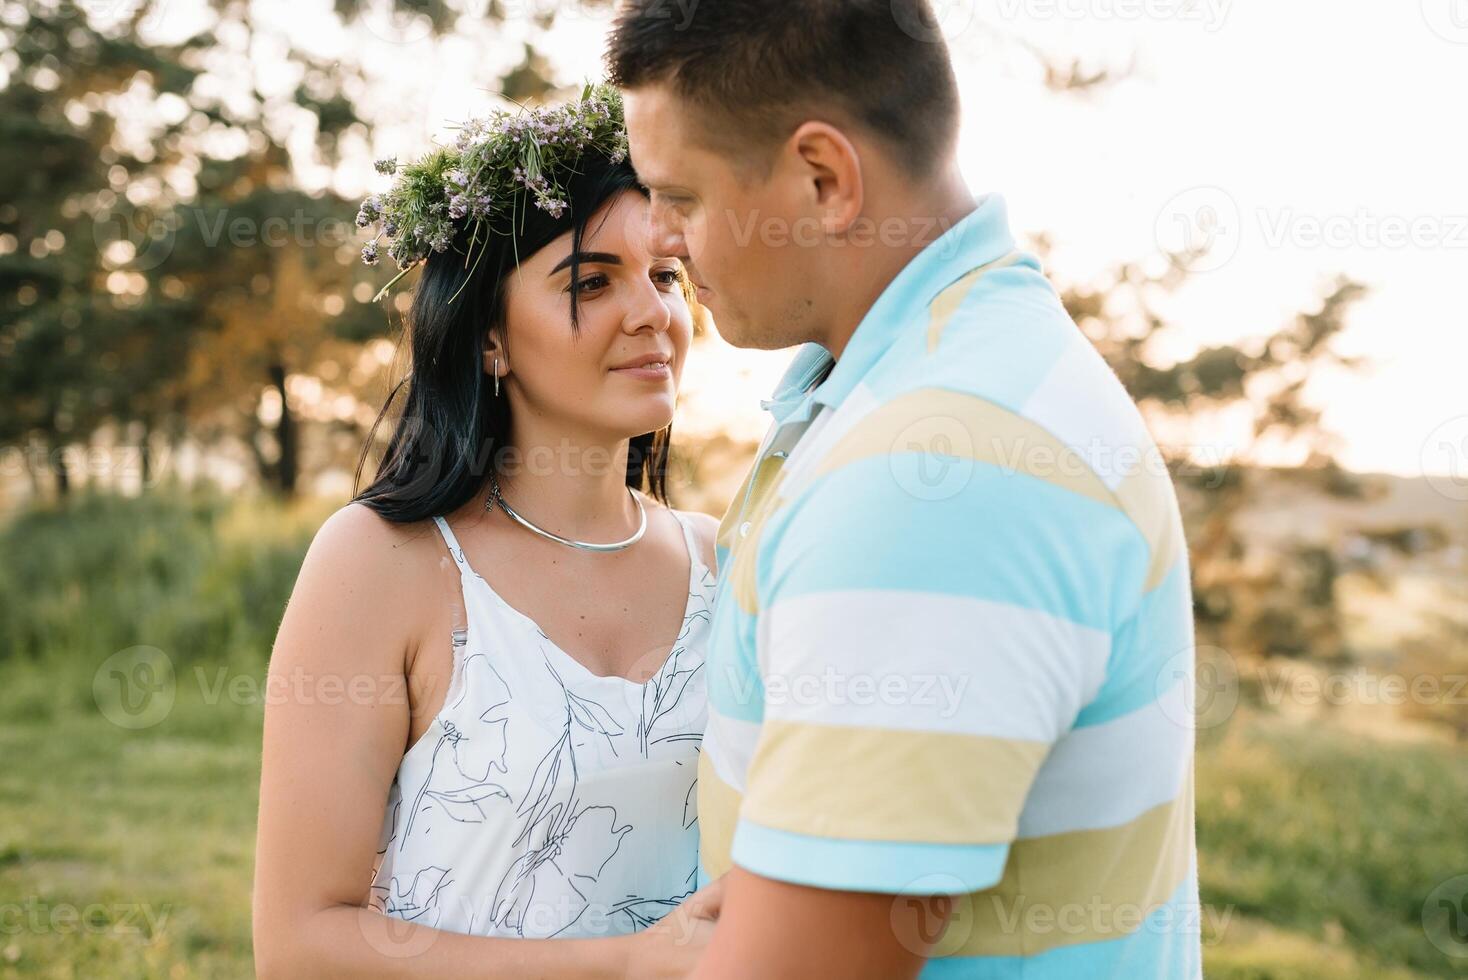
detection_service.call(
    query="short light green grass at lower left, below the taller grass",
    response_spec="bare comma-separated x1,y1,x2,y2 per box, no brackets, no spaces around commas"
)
0,665,261,979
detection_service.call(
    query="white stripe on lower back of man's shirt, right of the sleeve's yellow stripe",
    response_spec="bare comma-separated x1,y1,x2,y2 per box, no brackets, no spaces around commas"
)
1019,678,1193,838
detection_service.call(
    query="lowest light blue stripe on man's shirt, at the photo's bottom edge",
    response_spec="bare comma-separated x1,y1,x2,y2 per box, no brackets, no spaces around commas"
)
919,874,1202,980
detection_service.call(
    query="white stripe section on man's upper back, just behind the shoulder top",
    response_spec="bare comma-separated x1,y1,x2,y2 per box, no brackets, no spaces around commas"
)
1020,334,1161,490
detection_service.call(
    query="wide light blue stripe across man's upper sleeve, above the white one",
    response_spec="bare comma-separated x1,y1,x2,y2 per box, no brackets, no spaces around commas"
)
757,453,1148,631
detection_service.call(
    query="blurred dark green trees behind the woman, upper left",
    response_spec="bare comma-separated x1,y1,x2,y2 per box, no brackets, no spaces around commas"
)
0,0,578,494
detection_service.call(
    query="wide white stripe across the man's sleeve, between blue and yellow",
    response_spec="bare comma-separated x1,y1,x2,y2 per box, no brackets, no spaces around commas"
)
757,590,1111,742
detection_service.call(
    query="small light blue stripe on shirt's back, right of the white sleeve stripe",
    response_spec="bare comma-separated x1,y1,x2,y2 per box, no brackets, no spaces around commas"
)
1076,555,1193,728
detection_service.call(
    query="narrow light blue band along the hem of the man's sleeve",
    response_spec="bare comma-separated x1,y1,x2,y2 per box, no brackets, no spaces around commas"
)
731,820,1009,895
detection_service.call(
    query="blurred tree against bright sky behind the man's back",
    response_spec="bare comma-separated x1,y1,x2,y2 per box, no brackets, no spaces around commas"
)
1039,239,1365,659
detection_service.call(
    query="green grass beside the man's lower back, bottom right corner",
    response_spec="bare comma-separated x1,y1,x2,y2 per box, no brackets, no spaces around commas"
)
1198,713,1468,980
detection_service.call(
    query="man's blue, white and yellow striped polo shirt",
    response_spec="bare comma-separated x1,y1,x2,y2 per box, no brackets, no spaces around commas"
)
699,195,1201,980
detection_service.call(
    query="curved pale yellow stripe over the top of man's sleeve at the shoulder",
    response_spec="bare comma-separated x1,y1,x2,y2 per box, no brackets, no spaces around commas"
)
818,387,1117,508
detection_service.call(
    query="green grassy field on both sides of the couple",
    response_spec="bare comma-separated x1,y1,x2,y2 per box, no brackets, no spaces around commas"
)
0,496,1468,980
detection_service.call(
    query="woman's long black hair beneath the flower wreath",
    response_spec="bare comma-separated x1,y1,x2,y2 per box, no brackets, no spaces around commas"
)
352,153,672,522
